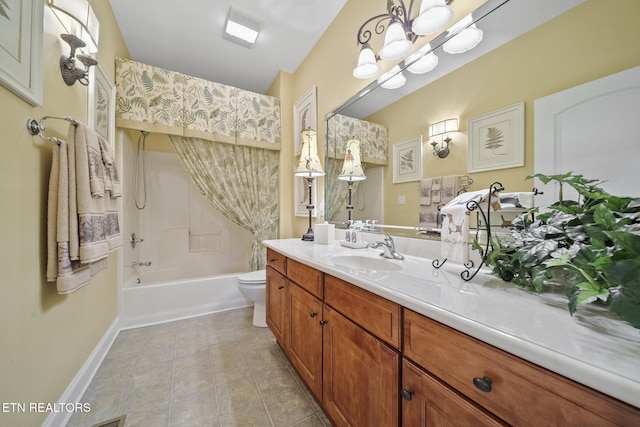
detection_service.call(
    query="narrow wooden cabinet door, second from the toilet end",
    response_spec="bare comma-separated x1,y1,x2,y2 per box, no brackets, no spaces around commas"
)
287,282,322,399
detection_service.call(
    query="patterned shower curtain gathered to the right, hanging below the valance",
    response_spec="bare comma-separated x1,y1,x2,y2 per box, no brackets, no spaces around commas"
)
170,135,279,271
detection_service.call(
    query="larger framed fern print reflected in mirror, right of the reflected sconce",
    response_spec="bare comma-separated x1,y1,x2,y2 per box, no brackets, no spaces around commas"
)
467,102,524,172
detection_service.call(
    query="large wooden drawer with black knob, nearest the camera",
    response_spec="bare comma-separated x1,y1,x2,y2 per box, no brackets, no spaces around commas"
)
403,309,640,426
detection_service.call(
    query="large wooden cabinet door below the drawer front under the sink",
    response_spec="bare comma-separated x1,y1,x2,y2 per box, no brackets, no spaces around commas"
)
322,305,400,427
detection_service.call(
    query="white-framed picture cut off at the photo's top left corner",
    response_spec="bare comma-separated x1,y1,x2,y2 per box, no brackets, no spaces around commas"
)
0,0,44,105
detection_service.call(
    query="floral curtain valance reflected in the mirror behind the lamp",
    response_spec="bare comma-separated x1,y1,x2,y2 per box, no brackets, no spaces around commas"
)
327,114,389,165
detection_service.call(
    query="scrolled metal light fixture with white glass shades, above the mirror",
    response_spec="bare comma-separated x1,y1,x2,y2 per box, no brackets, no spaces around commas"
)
353,0,453,79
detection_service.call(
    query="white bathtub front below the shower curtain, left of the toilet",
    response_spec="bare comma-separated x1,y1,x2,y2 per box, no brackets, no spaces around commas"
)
120,273,251,329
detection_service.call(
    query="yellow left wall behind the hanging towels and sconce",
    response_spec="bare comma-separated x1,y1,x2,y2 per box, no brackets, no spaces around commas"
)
0,0,129,427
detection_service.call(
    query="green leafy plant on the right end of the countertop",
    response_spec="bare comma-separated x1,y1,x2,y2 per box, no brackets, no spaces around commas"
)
476,172,640,328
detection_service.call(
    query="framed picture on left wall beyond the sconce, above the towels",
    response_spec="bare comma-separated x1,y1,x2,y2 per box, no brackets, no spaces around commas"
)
89,64,116,147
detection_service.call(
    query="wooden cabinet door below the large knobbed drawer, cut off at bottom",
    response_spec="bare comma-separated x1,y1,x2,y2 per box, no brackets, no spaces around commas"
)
402,360,506,427
